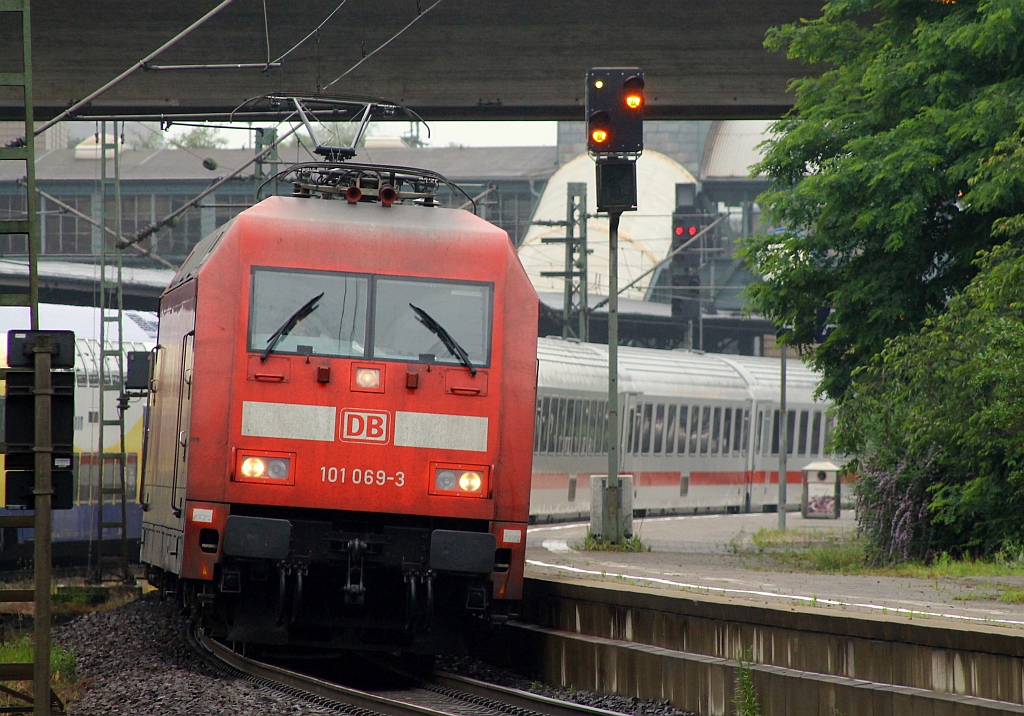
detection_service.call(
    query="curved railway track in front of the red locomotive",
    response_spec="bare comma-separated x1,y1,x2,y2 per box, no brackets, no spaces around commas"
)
189,634,622,716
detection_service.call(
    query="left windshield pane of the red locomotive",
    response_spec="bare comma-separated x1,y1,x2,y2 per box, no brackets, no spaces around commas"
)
249,268,370,356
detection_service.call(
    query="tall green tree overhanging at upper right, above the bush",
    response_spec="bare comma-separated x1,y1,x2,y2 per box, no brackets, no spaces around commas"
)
741,0,1024,401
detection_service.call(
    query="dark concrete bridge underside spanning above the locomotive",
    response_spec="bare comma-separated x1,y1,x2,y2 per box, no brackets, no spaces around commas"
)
0,0,821,120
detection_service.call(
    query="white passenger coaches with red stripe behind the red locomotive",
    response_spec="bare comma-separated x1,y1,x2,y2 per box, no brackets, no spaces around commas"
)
530,338,842,521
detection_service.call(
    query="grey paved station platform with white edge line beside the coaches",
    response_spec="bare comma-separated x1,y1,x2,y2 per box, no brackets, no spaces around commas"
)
526,511,1024,633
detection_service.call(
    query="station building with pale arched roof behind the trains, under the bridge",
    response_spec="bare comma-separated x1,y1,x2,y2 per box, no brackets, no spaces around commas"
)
0,121,773,354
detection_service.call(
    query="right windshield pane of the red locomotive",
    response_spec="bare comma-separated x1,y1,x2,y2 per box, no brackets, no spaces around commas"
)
373,278,492,368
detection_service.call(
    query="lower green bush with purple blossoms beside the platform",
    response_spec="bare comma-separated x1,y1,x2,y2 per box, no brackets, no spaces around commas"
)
839,244,1024,562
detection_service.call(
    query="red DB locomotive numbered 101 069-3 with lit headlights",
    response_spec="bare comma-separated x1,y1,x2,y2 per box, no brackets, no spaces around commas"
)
141,164,538,652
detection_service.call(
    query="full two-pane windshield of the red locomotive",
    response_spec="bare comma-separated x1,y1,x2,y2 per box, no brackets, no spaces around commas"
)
249,267,492,367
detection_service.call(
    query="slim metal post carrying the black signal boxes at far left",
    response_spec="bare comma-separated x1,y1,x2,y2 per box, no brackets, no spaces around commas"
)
32,335,53,716
